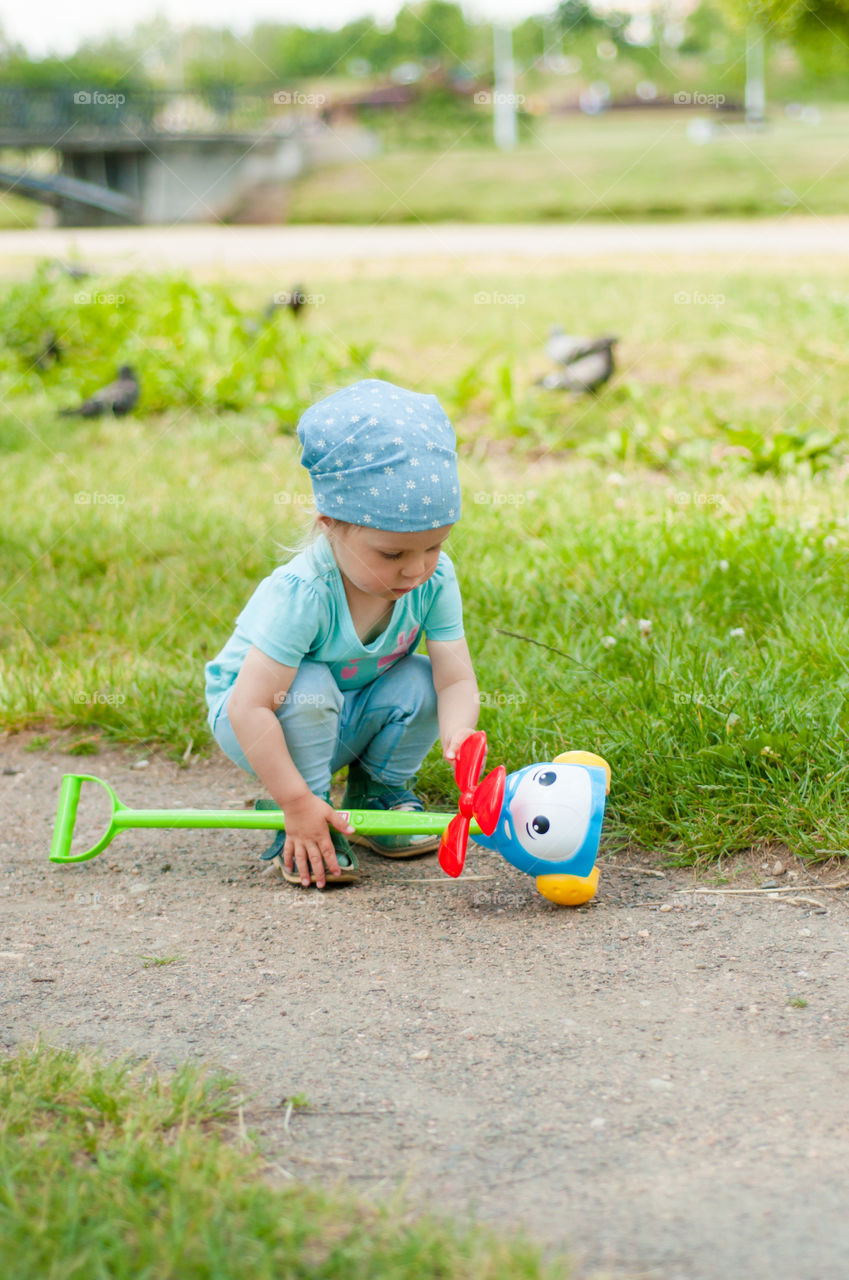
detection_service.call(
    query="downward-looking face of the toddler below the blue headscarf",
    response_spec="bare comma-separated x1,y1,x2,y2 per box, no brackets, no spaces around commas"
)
318,516,453,600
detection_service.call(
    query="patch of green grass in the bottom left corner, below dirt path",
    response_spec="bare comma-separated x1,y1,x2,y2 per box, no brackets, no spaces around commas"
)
0,1044,567,1280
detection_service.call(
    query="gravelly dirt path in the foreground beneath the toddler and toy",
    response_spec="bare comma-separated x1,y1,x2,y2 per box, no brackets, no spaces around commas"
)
0,735,849,1280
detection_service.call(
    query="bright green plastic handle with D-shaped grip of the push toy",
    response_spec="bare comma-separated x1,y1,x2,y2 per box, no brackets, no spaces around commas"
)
50,773,480,863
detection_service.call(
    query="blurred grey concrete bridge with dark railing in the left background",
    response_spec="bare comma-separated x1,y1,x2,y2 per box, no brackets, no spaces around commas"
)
0,87,376,227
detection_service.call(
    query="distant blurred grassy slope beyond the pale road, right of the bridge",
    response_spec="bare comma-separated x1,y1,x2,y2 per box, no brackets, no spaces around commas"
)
288,106,849,223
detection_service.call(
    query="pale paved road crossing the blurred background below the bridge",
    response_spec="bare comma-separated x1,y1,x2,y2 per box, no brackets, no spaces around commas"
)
0,216,849,274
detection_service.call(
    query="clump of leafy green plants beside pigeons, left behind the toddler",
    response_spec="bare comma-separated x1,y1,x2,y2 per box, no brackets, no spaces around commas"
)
0,264,369,429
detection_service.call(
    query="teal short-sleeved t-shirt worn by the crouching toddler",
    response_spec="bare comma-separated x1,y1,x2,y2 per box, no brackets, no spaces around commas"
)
205,538,464,726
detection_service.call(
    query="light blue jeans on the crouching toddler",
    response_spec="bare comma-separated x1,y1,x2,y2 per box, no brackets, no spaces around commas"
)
213,653,439,796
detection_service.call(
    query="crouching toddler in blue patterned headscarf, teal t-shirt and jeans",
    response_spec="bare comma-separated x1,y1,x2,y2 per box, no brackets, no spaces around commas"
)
206,379,479,888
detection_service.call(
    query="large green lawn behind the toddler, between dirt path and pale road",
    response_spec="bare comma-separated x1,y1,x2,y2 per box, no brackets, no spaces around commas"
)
0,264,849,861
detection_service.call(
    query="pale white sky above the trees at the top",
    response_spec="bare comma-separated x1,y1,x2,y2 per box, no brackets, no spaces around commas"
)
0,0,571,56
